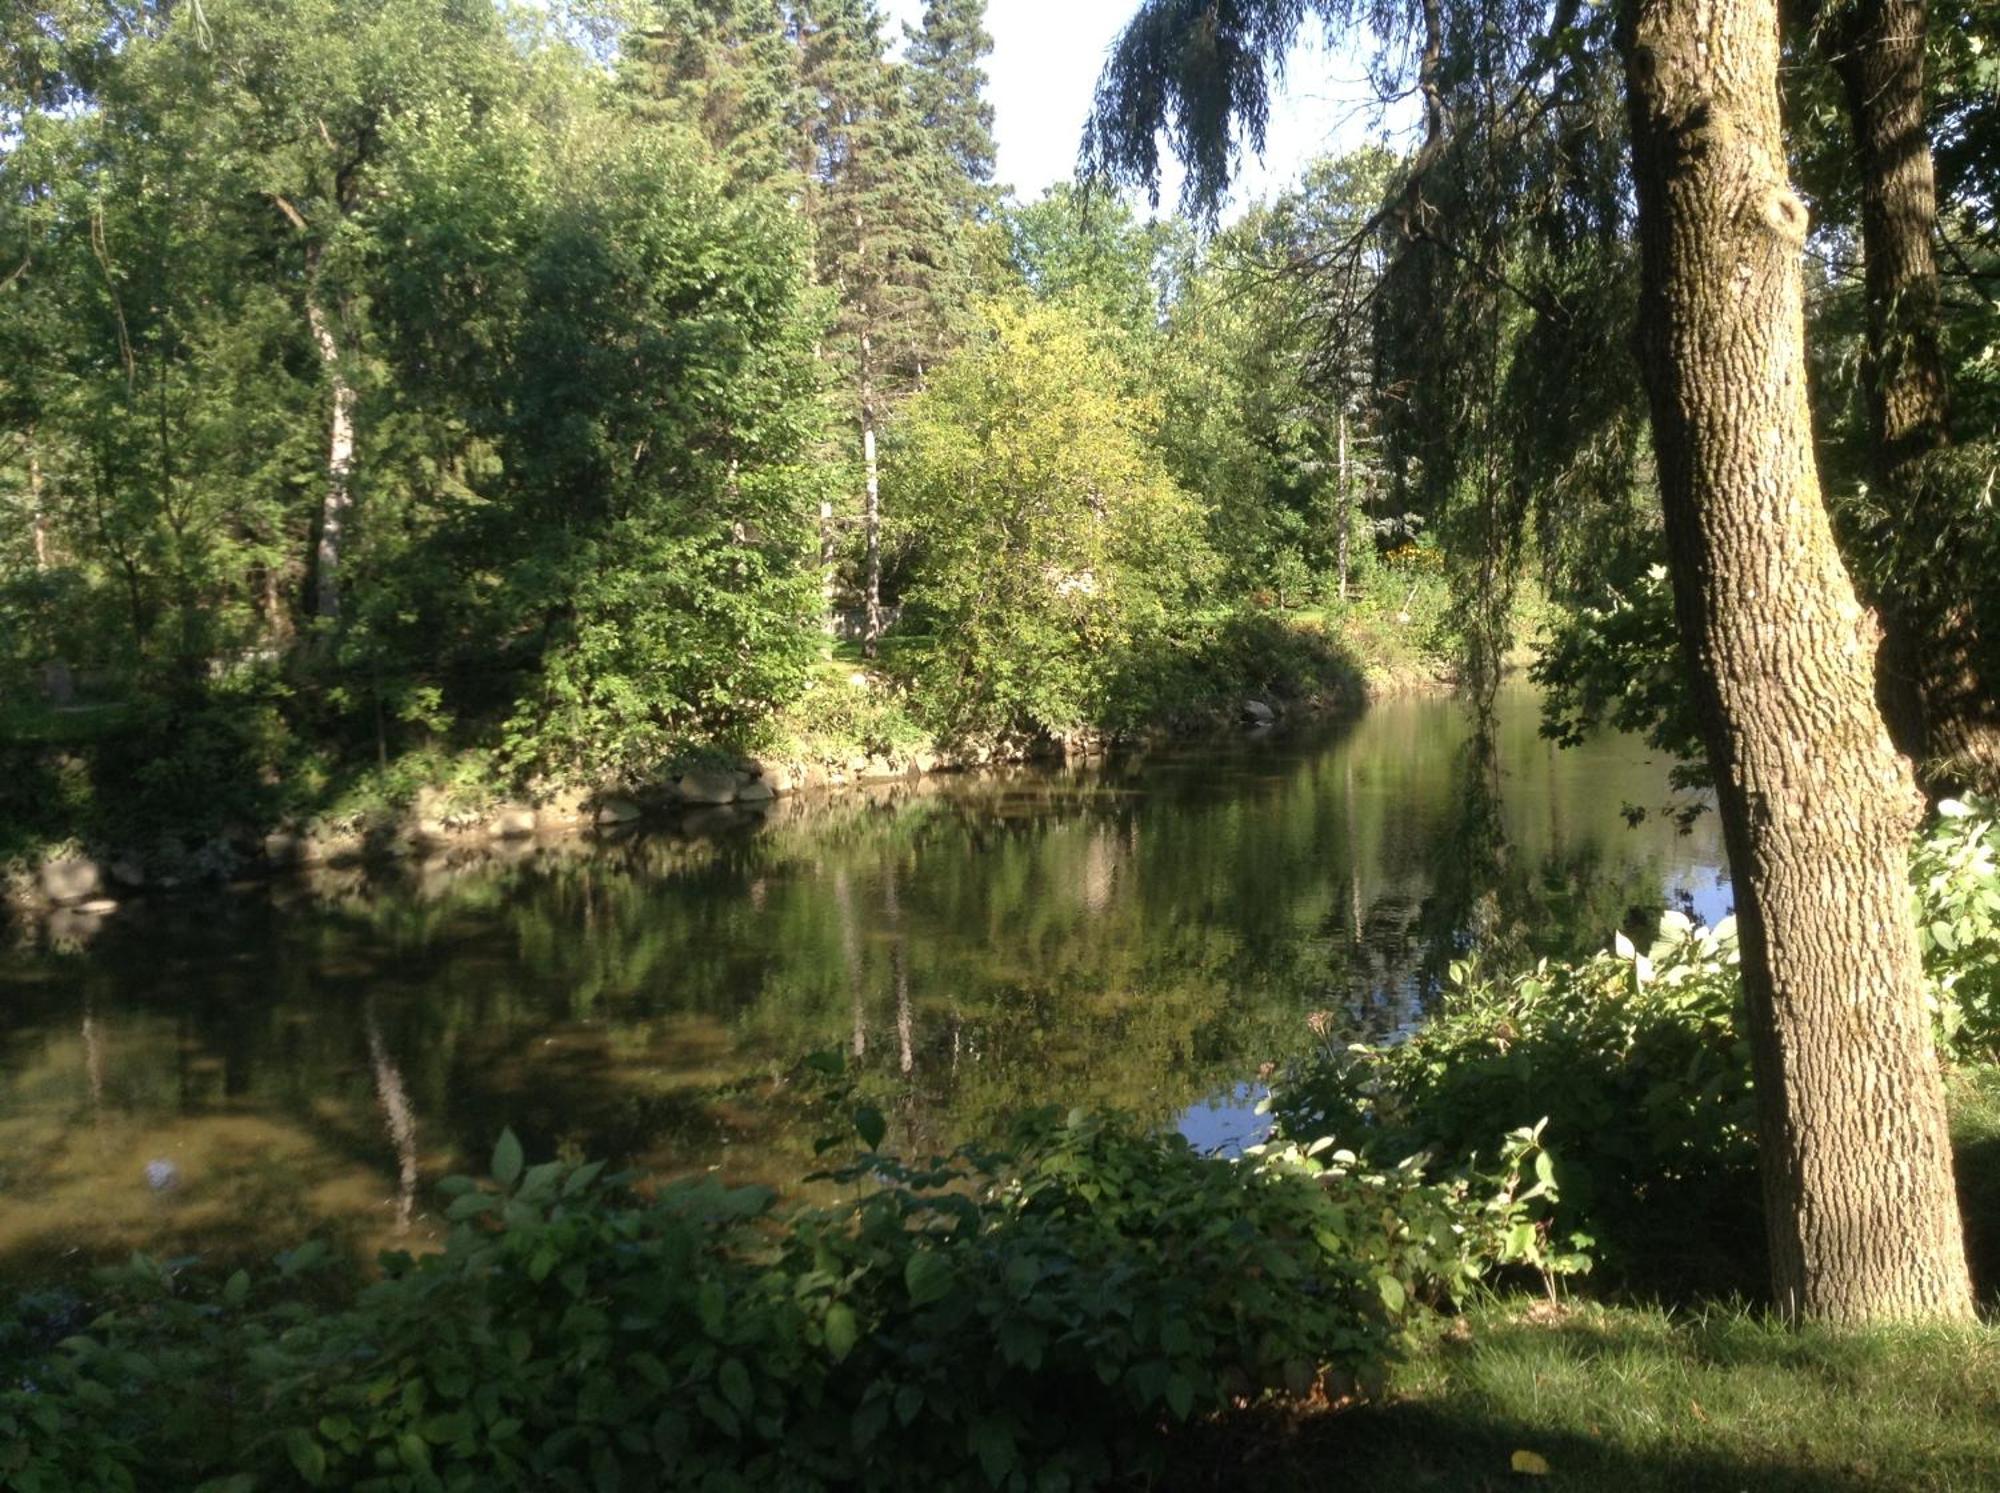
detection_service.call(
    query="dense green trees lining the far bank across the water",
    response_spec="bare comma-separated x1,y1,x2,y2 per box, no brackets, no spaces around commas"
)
0,0,1446,861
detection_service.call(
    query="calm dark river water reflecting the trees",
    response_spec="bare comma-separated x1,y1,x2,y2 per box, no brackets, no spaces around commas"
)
0,690,1728,1279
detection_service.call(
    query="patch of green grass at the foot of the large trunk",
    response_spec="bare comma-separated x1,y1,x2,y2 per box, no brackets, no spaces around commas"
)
1186,1299,2000,1493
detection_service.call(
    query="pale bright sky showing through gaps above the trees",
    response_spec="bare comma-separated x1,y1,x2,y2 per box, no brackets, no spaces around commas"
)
884,0,1416,210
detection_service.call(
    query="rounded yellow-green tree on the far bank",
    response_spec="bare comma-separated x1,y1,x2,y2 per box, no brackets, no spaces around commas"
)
892,302,1210,734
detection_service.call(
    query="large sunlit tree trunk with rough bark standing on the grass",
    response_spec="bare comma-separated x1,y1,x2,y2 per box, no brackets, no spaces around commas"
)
1620,0,1972,1321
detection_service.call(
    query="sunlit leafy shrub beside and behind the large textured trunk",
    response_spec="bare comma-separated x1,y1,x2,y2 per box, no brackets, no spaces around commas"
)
1274,803,2000,1291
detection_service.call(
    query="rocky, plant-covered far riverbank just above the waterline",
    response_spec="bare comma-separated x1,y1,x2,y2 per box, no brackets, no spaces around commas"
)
0,592,1450,920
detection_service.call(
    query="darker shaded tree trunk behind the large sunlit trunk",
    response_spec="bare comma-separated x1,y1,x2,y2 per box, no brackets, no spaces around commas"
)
1818,0,2000,785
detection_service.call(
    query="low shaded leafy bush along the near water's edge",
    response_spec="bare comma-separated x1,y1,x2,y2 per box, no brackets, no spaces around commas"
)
0,1111,1548,1493
